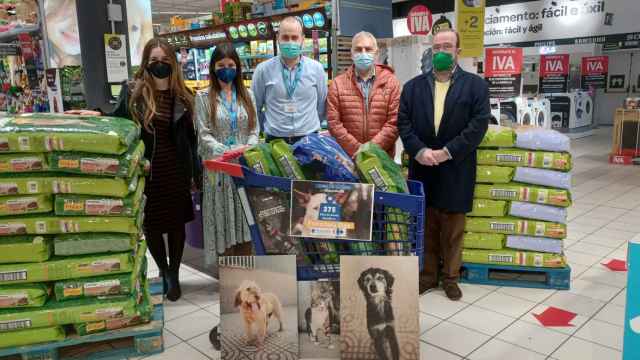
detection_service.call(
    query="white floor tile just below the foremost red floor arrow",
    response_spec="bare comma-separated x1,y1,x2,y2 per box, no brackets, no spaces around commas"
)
497,321,569,355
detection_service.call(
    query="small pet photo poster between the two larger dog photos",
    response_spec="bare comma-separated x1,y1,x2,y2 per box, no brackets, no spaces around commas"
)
298,279,340,360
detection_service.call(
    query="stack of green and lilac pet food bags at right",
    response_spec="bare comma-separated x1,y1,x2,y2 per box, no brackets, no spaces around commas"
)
463,125,571,268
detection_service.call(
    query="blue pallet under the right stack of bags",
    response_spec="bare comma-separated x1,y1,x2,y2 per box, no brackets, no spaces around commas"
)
460,263,571,290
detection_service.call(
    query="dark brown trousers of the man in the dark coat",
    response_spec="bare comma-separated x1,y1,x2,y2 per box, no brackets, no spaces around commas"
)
420,208,465,284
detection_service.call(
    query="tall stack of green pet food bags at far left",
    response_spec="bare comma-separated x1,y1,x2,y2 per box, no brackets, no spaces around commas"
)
0,114,152,347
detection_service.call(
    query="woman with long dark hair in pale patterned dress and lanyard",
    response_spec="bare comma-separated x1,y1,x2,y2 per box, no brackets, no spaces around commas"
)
196,43,260,269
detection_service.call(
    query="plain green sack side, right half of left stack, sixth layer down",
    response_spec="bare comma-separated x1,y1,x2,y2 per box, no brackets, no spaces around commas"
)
53,233,139,256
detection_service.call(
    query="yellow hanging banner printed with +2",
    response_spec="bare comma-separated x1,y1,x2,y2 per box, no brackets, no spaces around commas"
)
456,0,485,57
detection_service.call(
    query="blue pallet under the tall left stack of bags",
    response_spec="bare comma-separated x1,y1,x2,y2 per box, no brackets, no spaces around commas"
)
0,280,164,360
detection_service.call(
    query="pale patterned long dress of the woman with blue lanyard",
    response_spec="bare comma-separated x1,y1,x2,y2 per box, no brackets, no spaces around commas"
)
196,90,260,269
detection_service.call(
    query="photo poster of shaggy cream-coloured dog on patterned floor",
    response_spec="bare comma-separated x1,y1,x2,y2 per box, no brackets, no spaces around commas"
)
219,255,299,360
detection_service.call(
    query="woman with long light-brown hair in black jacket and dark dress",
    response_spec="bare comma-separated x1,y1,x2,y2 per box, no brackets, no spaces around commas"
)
70,38,202,301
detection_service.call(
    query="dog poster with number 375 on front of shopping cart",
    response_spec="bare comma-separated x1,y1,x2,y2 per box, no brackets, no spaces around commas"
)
290,180,374,241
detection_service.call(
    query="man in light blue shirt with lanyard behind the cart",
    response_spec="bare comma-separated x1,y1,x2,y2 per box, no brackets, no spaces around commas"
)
251,17,327,144
